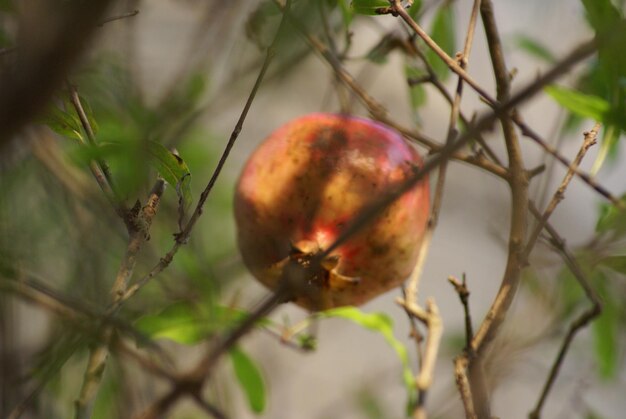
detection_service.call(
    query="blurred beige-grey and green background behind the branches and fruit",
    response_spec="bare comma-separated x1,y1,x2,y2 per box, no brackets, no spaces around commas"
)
0,0,626,419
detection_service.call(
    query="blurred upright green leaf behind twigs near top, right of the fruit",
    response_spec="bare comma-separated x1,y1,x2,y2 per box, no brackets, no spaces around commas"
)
426,2,456,80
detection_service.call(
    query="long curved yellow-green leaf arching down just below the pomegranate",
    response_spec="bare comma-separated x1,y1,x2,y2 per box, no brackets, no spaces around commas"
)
316,307,416,408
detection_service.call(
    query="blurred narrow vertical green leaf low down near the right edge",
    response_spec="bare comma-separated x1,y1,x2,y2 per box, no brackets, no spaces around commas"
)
592,271,619,379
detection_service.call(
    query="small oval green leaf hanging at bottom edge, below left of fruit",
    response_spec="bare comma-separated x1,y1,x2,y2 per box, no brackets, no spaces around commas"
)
228,346,266,413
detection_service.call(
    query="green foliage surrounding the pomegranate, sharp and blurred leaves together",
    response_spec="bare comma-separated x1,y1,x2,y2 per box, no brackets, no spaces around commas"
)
0,0,626,418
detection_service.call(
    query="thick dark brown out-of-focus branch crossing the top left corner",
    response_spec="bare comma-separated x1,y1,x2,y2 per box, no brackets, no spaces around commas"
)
0,0,112,153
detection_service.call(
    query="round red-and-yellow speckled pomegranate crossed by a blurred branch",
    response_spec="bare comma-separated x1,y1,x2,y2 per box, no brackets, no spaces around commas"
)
235,113,429,310
